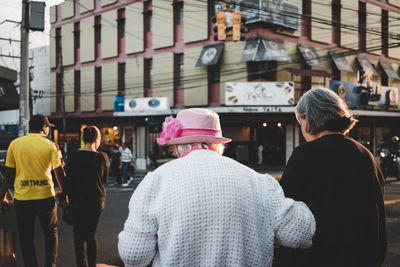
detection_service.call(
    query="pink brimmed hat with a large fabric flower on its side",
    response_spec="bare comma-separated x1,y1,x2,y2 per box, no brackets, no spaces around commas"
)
157,108,232,145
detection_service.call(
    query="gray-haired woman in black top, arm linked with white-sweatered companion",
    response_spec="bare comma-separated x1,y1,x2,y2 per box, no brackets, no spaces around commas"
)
275,88,387,267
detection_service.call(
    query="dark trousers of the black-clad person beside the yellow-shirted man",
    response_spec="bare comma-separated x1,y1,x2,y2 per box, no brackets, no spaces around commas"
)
74,200,104,267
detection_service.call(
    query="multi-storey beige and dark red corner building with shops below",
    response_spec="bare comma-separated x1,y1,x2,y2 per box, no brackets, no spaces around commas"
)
50,0,400,169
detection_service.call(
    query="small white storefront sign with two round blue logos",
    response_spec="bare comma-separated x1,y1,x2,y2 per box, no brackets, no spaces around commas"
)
124,97,169,112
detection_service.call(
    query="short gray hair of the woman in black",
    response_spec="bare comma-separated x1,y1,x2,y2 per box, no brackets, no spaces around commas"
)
295,88,357,134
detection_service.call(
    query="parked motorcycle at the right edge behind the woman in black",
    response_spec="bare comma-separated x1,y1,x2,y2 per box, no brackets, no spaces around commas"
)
379,136,400,180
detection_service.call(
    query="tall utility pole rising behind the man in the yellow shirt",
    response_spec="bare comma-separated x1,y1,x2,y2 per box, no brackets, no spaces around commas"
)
18,0,29,136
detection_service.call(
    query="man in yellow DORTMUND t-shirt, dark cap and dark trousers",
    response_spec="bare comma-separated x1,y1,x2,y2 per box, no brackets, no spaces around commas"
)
0,114,64,267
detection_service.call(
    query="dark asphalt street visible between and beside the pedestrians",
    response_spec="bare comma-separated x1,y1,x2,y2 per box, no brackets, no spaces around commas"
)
0,176,400,267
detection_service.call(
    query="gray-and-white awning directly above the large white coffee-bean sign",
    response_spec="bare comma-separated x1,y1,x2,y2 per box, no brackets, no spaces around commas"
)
241,38,291,62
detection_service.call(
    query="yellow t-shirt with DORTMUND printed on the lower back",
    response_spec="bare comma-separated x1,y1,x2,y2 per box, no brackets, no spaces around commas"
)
6,133,61,200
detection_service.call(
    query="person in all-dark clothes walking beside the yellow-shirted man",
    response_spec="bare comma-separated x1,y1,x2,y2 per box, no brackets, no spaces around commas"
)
65,125,108,267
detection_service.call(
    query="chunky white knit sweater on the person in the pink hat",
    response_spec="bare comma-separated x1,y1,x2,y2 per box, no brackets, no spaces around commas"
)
118,150,315,267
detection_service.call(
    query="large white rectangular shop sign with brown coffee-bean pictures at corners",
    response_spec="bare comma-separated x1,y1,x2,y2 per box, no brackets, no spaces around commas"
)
225,82,294,106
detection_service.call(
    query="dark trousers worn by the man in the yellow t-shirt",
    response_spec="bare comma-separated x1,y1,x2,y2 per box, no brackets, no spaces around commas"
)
14,197,58,267
